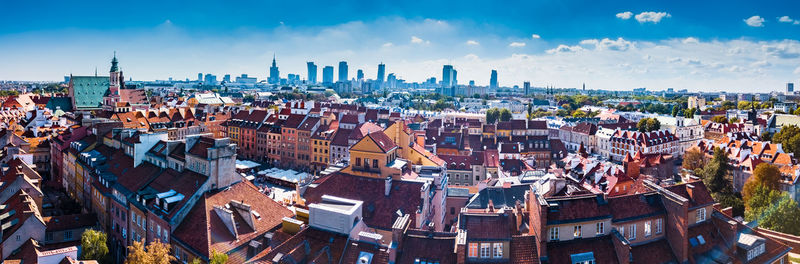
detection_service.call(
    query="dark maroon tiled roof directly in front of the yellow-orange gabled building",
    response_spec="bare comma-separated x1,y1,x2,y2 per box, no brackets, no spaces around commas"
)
303,172,424,230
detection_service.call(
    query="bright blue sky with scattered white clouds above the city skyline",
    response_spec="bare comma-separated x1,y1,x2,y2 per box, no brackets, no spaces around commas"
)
0,0,800,91
